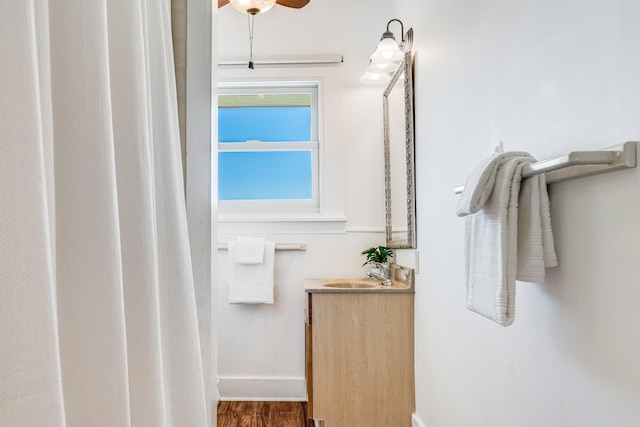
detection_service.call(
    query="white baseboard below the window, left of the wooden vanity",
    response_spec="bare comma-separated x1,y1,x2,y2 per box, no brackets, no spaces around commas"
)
218,376,307,402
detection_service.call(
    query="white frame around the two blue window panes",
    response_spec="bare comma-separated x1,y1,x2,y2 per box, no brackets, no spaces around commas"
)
218,81,321,214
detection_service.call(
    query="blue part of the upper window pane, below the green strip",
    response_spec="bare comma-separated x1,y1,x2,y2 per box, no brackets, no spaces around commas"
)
218,107,311,142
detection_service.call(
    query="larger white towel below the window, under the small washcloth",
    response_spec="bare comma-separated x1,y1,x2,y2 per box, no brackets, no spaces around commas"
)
228,242,276,304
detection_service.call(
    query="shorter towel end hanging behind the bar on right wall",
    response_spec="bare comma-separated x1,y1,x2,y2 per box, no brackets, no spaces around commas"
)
516,174,558,283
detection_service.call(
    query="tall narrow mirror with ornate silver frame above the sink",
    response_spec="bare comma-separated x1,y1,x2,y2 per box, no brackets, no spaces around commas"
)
382,52,416,249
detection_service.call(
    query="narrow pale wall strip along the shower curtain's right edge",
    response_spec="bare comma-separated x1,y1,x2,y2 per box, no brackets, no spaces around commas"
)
184,0,217,427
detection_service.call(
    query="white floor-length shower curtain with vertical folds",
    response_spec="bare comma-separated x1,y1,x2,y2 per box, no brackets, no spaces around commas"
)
0,0,207,427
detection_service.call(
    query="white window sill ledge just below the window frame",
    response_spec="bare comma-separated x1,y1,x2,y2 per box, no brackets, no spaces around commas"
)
218,214,347,234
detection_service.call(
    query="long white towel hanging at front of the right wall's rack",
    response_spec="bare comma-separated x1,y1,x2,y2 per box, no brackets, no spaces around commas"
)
463,153,535,326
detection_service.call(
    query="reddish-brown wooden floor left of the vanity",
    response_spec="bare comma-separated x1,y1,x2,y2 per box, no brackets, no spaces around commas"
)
218,402,313,427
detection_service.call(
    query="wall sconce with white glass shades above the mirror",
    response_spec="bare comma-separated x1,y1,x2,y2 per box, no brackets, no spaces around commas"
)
360,19,413,84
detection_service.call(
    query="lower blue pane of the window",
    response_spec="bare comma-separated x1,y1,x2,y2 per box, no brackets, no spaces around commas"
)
218,150,312,200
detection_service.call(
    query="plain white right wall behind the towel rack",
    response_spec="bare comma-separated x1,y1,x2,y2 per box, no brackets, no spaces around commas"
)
395,0,640,427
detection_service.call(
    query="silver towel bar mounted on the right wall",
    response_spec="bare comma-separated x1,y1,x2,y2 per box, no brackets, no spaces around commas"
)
454,141,637,194
